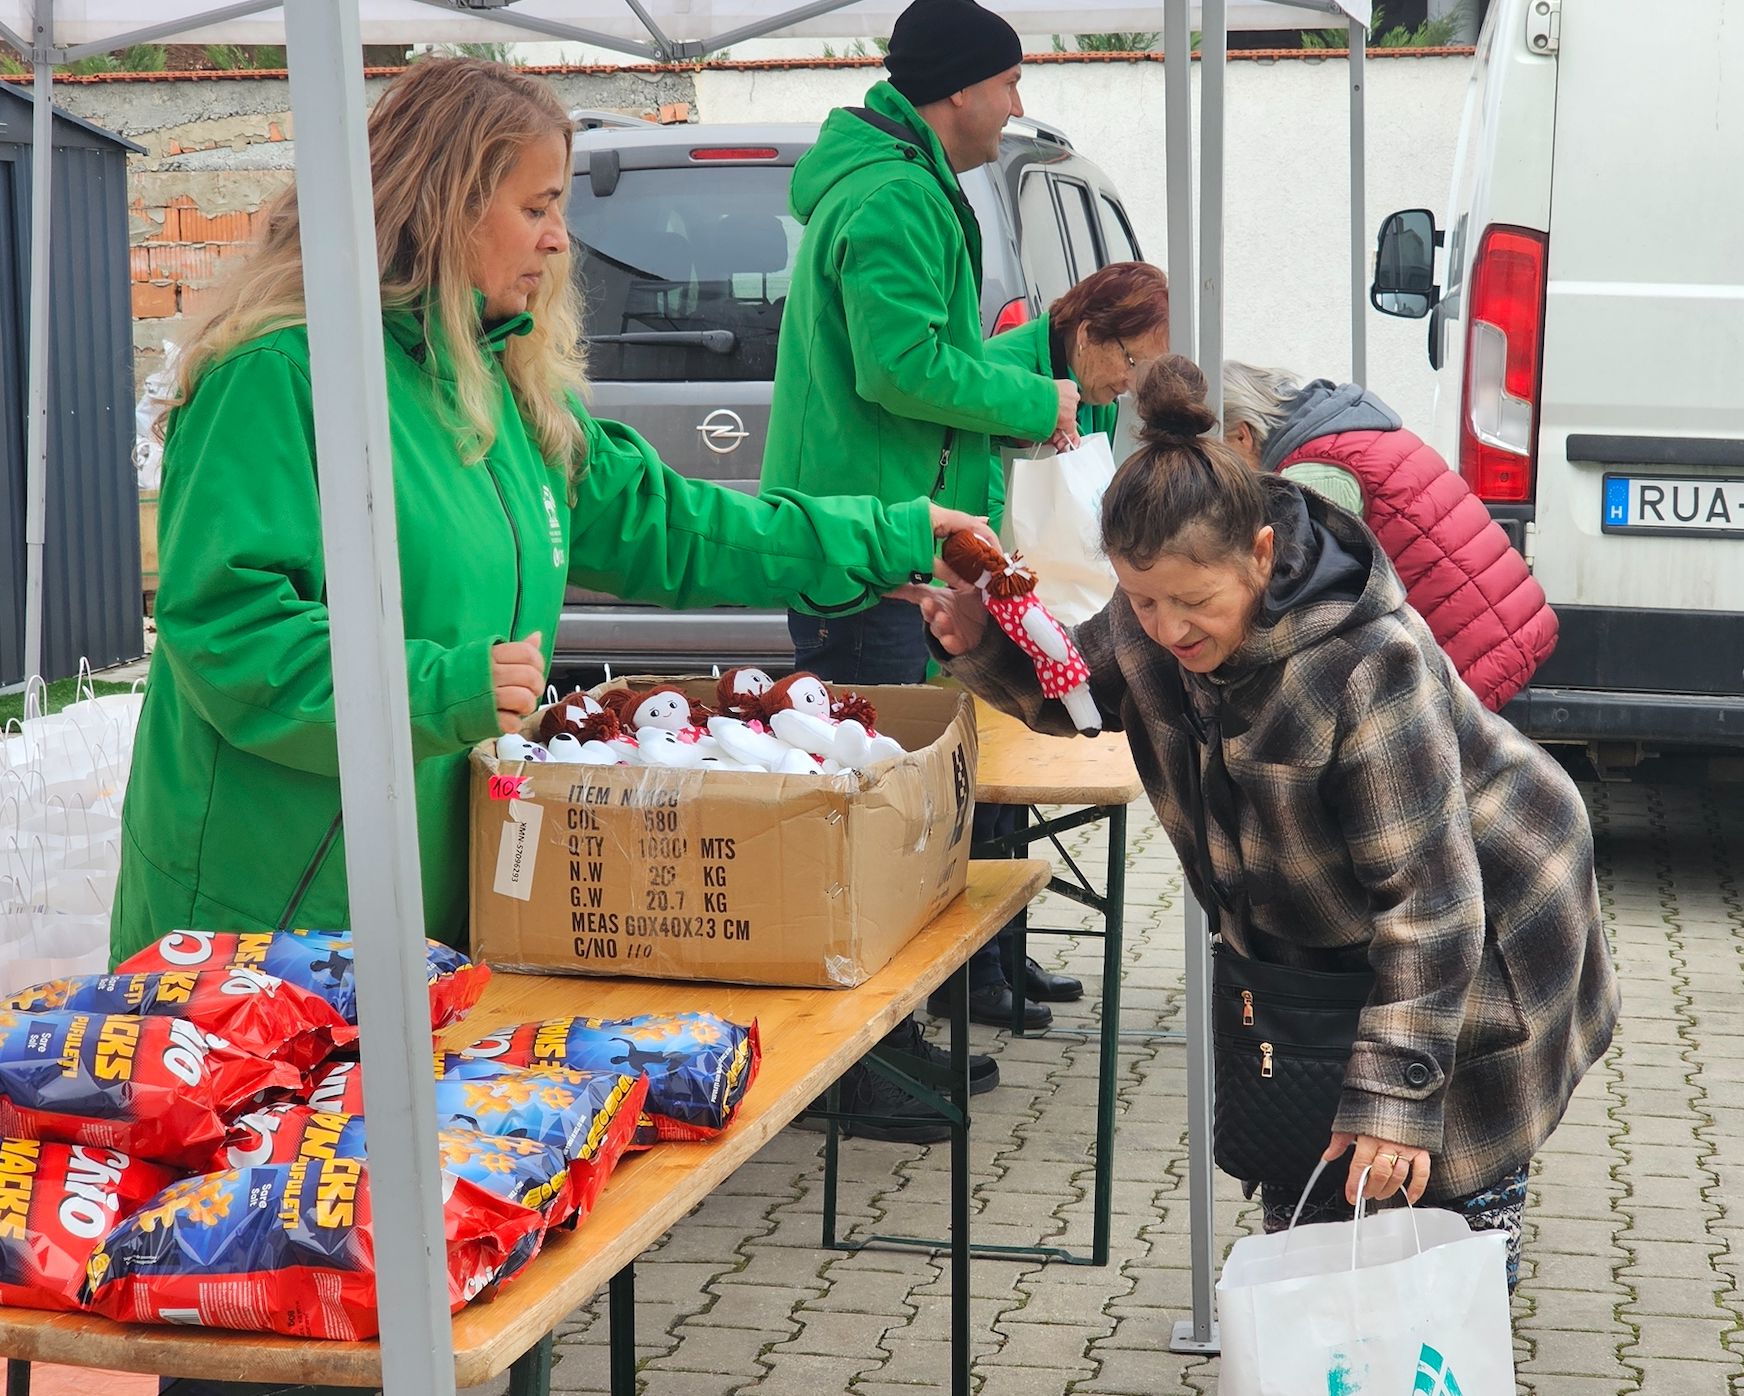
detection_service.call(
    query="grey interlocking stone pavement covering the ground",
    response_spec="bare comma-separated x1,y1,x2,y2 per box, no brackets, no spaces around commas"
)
467,785,1744,1396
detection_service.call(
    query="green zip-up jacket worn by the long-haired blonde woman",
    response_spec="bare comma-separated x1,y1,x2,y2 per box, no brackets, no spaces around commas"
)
110,309,933,960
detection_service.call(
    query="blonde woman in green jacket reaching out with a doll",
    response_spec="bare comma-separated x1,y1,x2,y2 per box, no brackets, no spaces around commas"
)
112,59,997,960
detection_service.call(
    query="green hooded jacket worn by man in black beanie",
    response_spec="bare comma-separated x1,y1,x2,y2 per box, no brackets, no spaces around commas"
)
762,82,1060,526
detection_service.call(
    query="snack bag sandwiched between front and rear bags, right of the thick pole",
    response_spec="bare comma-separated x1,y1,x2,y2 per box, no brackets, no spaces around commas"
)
309,1057,647,1215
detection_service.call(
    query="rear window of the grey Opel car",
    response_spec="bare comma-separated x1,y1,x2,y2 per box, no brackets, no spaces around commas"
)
569,166,800,382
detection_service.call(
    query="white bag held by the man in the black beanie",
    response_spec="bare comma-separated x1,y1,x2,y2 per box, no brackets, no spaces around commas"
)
999,431,1118,625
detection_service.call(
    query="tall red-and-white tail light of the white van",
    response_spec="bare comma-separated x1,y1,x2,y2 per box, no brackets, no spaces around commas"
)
1460,225,1549,504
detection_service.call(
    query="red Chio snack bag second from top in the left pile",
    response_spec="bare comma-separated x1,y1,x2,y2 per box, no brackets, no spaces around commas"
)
0,965,358,1071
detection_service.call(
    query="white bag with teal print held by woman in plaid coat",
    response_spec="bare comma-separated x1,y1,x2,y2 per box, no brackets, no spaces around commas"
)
1217,1172,1514,1396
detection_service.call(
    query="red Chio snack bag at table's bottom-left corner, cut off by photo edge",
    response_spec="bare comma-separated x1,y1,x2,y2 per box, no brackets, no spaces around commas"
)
0,1139,176,1309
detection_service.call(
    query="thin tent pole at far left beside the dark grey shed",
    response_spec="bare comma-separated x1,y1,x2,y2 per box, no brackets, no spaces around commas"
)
23,0,54,679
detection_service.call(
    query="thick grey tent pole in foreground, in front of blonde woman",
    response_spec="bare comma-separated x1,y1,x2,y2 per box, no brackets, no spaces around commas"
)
284,0,453,1396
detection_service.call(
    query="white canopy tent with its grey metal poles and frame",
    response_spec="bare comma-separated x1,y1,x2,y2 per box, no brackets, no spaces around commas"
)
0,0,1371,1375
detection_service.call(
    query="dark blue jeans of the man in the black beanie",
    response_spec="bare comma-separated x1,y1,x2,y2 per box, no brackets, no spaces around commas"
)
787,600,1017,989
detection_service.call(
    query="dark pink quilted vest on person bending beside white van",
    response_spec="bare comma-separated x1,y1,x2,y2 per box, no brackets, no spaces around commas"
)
1277,428,1556,712
